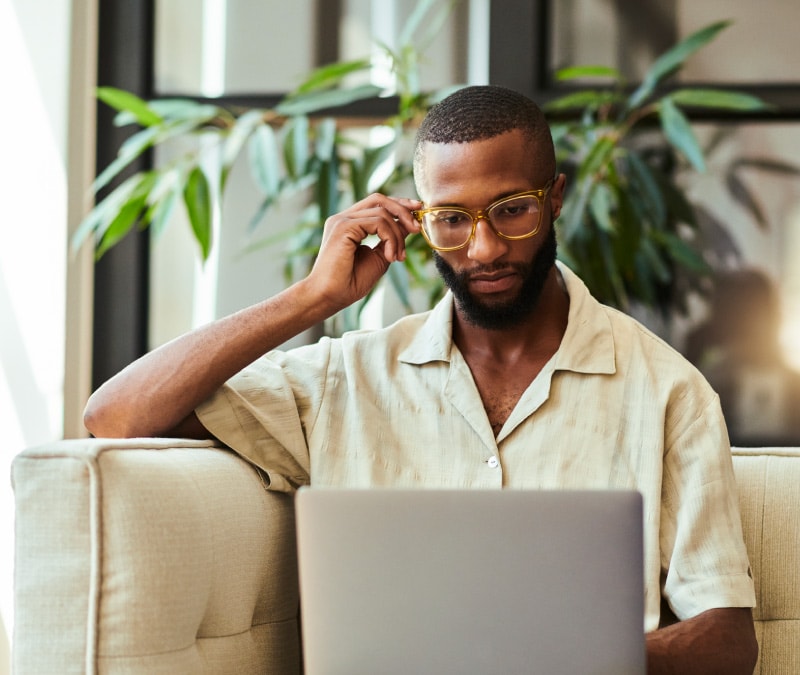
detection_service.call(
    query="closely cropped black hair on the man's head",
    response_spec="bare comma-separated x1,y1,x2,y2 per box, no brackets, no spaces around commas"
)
414,85,556,194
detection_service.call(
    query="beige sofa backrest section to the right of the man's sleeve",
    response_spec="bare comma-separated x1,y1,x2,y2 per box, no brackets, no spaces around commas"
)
733,448,800,675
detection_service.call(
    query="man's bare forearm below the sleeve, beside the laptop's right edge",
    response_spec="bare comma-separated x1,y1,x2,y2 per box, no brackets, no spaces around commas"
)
647,607,758,675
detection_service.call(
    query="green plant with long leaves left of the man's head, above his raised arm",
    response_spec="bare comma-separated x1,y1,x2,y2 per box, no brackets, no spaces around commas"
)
73,0,457,329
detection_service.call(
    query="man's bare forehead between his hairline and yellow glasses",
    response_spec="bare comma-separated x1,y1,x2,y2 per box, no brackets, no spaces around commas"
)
415,130,552,206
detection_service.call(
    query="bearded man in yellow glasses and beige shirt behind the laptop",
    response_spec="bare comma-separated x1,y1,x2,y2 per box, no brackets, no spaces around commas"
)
86,87,757,675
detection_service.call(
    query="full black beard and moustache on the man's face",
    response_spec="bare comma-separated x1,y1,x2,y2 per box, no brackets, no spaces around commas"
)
433,222,557,330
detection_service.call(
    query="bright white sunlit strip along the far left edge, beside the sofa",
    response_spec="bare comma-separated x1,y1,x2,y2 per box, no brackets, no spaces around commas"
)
0,0,70,656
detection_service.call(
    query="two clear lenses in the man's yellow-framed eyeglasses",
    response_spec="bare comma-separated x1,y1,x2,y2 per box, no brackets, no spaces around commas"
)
422,196,539,248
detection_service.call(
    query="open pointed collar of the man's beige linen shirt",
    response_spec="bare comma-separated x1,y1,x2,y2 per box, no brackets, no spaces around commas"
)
399,261,616,374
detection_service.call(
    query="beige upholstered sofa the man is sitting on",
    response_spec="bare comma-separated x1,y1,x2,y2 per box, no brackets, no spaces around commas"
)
12,439,800,675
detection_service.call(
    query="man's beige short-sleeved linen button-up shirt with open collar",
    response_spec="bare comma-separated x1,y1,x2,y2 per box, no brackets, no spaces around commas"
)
197,264,755,630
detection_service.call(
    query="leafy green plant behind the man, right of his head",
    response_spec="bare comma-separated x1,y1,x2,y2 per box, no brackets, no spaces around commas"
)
546,21,766,313
